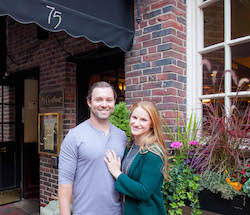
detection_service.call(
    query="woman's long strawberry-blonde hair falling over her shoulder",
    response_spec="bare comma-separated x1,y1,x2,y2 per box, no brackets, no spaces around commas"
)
130,101,169,180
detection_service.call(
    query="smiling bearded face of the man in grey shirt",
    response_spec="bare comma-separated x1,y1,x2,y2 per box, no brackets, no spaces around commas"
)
87,87,115,120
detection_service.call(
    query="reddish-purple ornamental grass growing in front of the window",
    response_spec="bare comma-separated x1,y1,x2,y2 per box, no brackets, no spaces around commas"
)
191,103,250,175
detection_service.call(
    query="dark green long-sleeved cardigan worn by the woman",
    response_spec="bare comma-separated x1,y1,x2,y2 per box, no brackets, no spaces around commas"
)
115,149,166,215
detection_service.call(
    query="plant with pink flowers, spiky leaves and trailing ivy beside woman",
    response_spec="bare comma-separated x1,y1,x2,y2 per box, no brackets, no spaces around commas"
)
162,114,201,215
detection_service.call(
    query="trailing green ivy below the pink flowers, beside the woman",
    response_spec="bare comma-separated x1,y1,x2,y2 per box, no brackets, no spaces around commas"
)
162,158,201,215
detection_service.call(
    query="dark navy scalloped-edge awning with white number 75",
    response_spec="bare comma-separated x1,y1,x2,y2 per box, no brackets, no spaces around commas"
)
0,0,134,51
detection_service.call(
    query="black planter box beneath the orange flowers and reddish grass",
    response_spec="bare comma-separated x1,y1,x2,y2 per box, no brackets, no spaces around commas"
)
199,189,250,215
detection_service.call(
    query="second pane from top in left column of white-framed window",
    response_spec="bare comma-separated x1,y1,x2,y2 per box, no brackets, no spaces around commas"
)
202,49,225,95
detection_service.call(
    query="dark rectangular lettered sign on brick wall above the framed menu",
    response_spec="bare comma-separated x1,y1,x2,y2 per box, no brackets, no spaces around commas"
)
39,89,64,108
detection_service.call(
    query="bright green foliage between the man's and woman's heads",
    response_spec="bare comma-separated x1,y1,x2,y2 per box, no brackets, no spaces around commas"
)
109,102,130,139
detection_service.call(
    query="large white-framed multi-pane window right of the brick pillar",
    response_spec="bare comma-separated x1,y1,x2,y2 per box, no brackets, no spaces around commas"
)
187,0,250,123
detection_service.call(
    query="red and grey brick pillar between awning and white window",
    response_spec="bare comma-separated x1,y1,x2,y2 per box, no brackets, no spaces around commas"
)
125,0,186,134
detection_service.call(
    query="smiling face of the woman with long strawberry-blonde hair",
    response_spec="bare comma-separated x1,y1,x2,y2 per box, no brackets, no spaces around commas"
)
129,107,152,138
